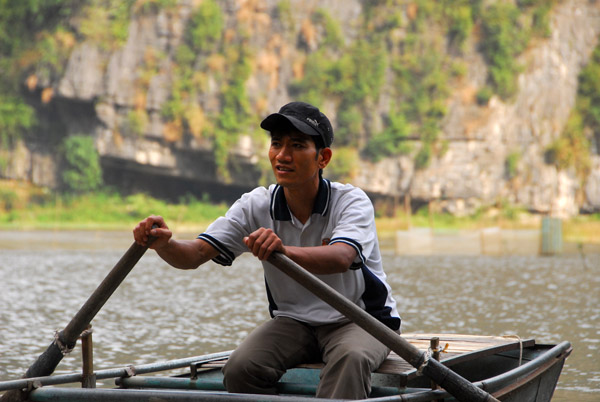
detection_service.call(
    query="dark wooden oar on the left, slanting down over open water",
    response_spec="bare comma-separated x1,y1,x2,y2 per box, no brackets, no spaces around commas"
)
0,238,154,402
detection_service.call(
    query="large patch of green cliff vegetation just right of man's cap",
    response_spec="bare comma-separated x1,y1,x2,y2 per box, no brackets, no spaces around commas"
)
291,0,554,168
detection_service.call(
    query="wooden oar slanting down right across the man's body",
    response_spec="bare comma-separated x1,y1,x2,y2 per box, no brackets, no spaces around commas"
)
268,253,498,402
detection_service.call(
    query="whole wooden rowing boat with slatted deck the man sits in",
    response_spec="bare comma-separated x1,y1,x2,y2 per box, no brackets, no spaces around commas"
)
0,334,571,402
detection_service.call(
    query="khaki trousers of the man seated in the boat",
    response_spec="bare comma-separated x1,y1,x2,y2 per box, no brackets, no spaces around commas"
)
223,317,390,399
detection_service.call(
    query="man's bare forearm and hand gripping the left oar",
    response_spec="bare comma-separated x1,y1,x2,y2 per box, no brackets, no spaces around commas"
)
133,215,219,269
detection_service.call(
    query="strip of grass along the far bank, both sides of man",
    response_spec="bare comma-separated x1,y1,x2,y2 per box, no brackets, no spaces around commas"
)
0,181,600,244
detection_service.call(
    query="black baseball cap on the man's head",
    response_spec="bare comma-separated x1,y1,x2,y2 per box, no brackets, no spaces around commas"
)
260,102,333,148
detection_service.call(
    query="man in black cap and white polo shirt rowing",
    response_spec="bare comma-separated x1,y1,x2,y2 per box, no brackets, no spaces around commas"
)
134,102,400,399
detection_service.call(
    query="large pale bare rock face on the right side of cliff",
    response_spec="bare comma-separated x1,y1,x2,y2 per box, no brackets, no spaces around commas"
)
357,1,600,216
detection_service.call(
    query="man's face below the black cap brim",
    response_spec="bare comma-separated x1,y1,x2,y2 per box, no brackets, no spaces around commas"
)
269,131,327,188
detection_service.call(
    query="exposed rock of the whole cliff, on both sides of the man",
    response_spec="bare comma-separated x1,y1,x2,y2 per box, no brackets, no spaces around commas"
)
6,0,600,216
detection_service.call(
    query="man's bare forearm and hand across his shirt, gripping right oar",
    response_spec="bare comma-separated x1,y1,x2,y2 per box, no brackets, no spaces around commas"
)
244,228,356,274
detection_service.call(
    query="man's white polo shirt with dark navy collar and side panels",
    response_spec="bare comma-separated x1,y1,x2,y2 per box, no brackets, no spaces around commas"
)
198,179,400,330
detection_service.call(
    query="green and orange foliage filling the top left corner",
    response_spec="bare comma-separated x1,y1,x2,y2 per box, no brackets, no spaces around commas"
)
0,0,176,149
